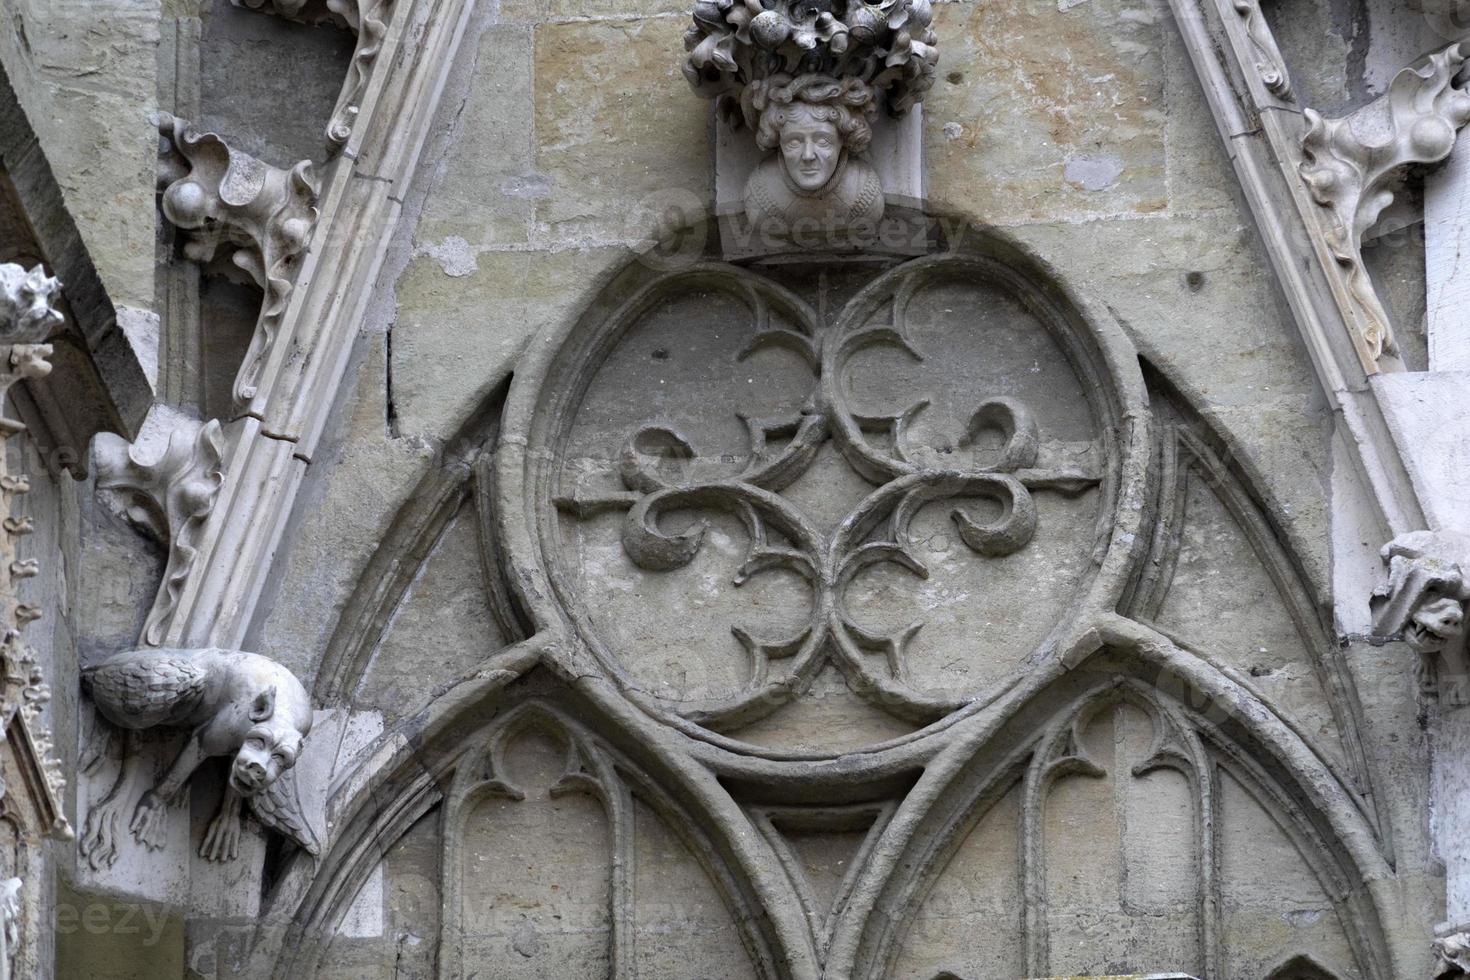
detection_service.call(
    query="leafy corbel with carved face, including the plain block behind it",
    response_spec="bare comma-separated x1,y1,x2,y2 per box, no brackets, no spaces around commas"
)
684,0,939,259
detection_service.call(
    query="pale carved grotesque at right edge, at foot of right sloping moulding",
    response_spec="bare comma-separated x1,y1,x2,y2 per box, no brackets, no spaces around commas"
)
1372,530,1470,704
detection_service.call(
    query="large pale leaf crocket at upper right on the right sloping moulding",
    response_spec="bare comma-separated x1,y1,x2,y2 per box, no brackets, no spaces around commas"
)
1301,41,1470,367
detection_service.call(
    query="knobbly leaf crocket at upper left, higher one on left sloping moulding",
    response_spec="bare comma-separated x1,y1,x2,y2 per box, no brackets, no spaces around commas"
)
154,113,319,404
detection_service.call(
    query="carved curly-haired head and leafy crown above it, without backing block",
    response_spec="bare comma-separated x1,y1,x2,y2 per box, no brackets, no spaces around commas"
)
684,0,939,234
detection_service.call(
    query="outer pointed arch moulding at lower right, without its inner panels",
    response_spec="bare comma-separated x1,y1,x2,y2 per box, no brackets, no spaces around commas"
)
833,617,1397,980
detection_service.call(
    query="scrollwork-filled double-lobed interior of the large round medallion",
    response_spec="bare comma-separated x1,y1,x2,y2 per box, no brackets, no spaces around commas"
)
497,240,1147,746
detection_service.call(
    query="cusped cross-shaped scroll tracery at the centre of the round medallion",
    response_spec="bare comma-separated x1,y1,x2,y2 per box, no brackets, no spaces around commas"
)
556,257,1104,726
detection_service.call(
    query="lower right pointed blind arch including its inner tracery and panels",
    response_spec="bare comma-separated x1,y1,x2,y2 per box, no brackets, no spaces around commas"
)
846,617,1402,980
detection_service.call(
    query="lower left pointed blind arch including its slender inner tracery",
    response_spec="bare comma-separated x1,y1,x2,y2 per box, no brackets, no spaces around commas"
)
253,667,820,980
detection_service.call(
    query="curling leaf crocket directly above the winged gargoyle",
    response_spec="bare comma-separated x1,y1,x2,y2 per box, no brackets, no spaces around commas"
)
93,419,225,646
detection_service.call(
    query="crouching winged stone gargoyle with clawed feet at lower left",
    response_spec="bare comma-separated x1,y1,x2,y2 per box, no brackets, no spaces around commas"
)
81,649,319,868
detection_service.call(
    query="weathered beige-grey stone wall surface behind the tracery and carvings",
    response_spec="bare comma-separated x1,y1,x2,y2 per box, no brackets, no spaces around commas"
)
0,0,1444,980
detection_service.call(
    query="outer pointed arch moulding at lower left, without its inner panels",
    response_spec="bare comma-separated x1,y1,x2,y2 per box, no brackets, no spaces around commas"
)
254,639,820,980
